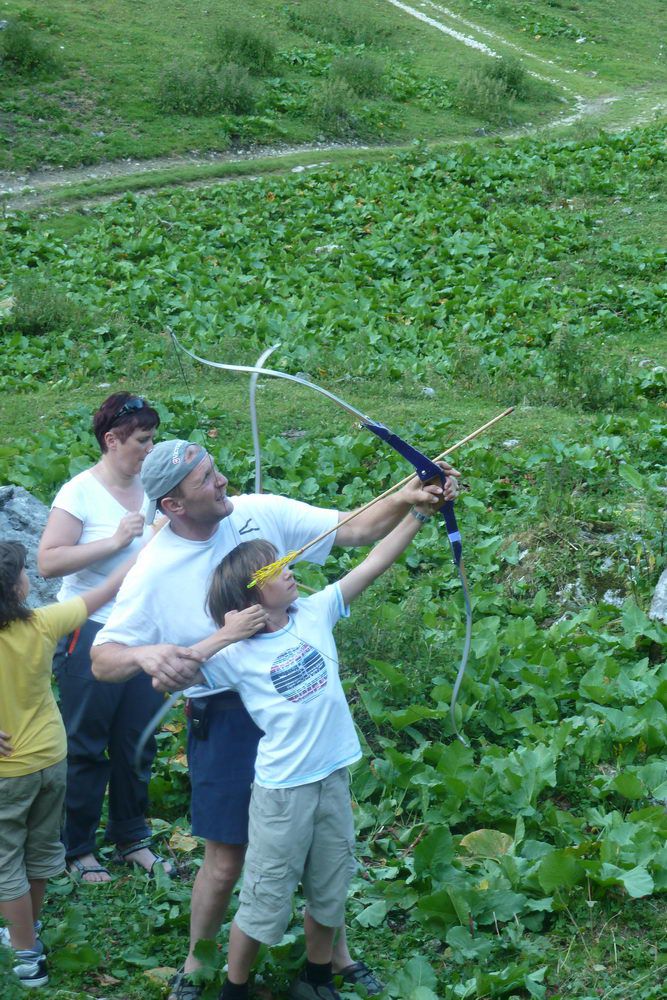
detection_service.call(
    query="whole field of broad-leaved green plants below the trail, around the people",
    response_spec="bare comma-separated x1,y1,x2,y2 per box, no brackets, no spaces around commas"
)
0,103,667,1000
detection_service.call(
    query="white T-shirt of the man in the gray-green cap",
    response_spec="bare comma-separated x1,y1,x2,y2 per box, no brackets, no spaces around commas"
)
94,494,338,697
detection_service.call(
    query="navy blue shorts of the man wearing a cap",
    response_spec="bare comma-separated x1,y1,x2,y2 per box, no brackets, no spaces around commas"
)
188,691,264,844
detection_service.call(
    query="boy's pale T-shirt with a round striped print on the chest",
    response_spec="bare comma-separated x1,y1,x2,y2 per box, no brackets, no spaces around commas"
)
202,583,361,788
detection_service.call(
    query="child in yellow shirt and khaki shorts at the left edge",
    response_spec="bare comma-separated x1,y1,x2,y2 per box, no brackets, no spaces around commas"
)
0,542,133,987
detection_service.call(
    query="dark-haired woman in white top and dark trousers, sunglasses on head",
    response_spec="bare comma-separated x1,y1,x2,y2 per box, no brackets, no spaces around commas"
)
38,392,170,882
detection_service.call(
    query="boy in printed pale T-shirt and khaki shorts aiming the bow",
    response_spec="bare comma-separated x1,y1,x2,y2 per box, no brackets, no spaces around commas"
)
188,506,433,1000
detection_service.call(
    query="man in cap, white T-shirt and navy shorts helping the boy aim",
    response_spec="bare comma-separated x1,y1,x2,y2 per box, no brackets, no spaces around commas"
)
92,440,457,1000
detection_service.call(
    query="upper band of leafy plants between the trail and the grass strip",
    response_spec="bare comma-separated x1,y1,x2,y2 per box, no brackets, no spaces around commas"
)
0,127,666,410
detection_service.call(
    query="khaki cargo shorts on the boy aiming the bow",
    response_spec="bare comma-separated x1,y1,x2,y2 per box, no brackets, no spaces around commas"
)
235,767,356,945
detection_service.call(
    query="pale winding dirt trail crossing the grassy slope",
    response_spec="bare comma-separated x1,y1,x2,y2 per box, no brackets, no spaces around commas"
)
0,0,667,212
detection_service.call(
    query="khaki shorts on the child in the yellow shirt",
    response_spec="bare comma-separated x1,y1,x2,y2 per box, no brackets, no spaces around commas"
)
0,760,67,902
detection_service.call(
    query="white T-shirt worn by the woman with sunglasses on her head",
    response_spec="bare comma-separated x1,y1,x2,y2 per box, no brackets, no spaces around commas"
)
51,469,153,623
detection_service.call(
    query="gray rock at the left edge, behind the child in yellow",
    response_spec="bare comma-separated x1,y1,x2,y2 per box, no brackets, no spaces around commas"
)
0,486,60,608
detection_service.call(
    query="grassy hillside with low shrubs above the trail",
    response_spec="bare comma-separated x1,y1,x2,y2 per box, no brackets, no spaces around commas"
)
0,0,665,170
